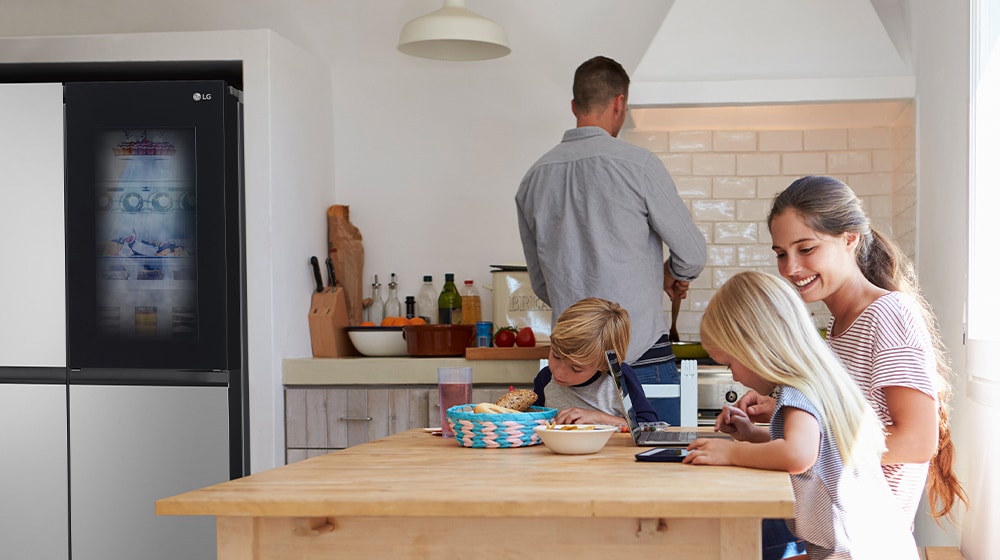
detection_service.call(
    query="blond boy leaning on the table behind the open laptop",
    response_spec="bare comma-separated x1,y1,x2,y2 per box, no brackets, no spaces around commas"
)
535,298,658,428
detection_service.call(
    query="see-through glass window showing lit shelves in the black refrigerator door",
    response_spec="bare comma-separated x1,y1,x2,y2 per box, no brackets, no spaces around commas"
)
94,128,198,340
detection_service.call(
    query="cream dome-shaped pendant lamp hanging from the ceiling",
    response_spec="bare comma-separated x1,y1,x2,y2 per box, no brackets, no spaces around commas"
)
397,0,510,60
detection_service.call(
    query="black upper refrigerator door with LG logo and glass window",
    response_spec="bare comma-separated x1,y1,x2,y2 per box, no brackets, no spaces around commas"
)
65,81,243,370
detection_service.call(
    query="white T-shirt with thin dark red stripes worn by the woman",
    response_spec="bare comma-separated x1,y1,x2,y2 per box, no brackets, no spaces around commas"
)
827,292,937,523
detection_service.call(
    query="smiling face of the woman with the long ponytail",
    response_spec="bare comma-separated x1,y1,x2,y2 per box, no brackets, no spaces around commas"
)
771,210,858,303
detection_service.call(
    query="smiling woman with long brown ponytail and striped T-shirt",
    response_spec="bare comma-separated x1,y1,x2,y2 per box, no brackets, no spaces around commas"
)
738,176,968,523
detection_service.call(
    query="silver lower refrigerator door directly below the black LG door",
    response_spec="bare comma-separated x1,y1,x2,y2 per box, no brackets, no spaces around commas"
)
69,385,229,560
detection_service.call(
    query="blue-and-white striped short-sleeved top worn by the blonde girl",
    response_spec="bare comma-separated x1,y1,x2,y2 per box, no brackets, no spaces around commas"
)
770,387,917,560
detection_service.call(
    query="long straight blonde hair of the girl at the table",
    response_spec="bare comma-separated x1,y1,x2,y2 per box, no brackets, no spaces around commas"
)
701,271,885,466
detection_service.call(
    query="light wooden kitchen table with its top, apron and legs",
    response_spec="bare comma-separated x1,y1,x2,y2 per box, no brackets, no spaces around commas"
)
156,429,794,560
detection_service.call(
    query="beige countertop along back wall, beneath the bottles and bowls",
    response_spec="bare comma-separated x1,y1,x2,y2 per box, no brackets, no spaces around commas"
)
281,357,540,386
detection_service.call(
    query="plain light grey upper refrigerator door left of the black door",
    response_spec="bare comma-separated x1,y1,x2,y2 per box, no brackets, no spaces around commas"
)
0,84,66,367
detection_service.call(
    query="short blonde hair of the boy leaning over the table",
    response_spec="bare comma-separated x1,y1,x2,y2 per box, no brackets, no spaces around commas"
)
549,298,631,371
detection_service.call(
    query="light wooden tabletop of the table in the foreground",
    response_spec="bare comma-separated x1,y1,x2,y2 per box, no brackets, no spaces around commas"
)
156,429,794,518
